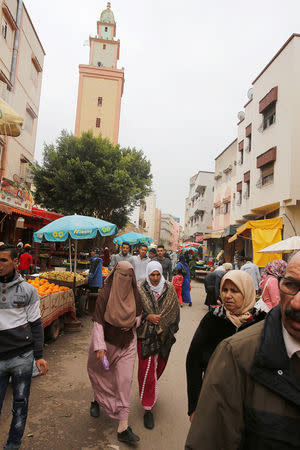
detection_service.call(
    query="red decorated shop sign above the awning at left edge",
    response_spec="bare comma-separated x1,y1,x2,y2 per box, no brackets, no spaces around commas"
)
0,177,33,211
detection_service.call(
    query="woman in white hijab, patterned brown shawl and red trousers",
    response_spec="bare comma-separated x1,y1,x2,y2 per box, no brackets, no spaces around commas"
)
137,261,180,430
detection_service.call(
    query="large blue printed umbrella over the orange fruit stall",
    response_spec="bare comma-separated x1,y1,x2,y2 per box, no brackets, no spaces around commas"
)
33,214,118,272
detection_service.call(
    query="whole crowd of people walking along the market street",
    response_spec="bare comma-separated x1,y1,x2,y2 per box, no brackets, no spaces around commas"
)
0,242,300,450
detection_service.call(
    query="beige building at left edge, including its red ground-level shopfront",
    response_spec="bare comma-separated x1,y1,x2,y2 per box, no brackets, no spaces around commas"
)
0,0,45,242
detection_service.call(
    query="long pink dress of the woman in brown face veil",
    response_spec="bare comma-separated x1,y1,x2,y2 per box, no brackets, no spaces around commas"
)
87,316,141,420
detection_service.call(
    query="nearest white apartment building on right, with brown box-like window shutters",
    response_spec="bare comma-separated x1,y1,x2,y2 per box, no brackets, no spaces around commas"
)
233,34,300,238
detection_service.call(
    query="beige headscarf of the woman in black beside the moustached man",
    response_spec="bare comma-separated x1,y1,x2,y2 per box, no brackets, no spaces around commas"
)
220,270,256,328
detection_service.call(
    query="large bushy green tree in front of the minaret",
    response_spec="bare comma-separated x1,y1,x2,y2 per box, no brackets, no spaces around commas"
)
31,131,152,228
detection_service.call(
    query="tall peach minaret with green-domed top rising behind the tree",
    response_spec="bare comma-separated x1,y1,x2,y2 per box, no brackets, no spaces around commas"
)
75,3,124,144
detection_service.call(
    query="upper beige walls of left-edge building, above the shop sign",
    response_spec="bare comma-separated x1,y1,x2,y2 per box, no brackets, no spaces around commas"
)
0,0,45,186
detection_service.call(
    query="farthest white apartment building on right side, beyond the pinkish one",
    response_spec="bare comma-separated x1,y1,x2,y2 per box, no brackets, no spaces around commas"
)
184,170,215,239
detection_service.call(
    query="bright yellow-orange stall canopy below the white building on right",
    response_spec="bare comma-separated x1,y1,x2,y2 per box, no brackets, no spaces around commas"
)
228,217,282,267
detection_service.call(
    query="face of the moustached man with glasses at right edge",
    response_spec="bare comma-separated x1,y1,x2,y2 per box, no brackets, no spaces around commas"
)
280,252,300,341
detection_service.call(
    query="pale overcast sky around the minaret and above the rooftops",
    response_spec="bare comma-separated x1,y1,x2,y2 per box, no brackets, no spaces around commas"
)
25,0,300,218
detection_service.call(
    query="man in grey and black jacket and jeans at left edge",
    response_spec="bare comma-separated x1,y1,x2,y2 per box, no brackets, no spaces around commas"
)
0,244,48,449
